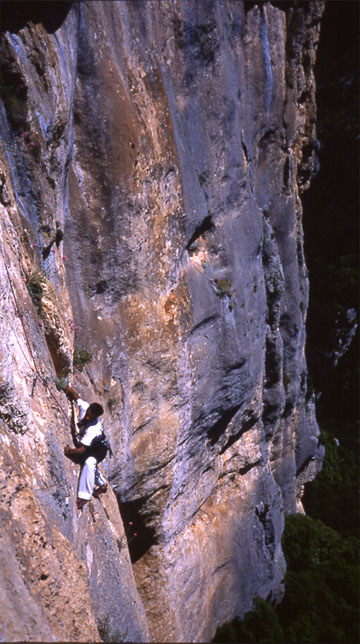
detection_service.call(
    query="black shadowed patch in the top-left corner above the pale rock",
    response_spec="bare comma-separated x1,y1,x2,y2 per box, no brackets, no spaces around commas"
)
0,0,73,34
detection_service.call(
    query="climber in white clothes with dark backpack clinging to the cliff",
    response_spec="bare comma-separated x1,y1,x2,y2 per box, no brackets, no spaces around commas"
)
64,385,109,510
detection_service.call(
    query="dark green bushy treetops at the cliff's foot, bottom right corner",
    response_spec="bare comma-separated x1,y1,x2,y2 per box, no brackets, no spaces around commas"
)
213,515,359,644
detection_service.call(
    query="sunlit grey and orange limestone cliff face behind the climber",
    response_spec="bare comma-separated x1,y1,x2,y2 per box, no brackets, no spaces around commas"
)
0,0,323,642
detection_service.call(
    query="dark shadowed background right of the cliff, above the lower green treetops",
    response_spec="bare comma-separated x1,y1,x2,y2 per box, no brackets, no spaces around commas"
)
303,0,359,535
